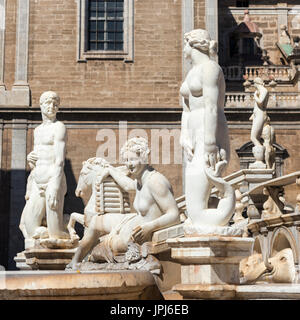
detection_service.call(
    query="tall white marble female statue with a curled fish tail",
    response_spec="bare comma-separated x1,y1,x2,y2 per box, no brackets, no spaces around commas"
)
180,29,235,232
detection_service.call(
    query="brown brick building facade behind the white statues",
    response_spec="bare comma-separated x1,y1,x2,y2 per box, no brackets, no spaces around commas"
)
0,0,300,269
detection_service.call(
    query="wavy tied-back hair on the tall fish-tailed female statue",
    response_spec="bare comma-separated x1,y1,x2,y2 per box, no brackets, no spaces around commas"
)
184,29,218,56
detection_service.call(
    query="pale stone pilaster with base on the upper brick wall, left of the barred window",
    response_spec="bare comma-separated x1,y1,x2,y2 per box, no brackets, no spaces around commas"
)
12,0,30,106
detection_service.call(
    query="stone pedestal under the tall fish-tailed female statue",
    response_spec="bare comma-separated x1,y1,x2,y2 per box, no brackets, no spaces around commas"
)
167,236,254,299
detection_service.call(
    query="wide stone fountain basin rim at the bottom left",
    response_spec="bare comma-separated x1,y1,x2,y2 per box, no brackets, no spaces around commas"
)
0,271,162,300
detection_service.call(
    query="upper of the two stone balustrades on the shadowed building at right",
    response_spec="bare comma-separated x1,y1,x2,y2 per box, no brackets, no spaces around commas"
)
244,66,296,82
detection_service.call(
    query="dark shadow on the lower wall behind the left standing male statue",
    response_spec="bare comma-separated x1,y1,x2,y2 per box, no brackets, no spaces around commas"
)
0,159,84,270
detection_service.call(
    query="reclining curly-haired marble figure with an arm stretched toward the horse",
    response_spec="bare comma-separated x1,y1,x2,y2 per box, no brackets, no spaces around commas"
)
67,137,180,269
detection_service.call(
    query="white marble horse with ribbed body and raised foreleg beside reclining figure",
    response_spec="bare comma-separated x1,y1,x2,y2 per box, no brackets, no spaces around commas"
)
67,157,130,240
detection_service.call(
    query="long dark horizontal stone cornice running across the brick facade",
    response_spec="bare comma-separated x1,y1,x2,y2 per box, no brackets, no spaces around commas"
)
0,107,300,128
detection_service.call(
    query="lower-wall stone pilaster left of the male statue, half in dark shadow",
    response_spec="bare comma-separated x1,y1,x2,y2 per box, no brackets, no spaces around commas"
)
8,119,27,269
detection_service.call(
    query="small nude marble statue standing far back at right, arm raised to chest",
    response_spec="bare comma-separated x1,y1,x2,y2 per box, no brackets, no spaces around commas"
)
249,78,269,147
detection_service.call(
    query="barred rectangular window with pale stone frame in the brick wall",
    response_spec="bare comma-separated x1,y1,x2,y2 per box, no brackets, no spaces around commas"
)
78,0,134,62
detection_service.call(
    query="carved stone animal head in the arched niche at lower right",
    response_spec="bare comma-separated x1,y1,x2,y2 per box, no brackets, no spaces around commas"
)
240,248,296,284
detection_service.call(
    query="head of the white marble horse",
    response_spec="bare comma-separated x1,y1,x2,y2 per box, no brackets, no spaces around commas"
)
75,158,108,198
